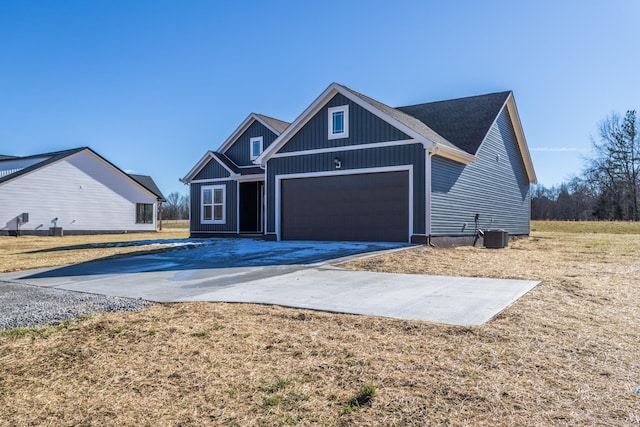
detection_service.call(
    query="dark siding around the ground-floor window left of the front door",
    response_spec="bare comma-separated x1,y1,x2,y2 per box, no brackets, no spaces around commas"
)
189,180,238,233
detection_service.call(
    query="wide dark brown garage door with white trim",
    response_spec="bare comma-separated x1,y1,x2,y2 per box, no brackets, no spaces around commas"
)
280,171,409,242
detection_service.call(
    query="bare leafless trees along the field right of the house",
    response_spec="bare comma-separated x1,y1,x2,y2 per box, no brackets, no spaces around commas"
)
531,110,640,221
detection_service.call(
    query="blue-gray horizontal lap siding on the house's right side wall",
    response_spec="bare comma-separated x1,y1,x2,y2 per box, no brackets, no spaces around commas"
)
431,109,530,236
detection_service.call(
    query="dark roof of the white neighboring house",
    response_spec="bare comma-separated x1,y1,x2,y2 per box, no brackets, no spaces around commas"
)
0,147,164,201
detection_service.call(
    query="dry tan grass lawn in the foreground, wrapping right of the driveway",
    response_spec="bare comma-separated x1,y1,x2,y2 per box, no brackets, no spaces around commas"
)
0,226,640,426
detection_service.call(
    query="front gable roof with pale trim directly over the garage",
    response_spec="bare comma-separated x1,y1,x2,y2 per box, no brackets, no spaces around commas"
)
254,83,475,165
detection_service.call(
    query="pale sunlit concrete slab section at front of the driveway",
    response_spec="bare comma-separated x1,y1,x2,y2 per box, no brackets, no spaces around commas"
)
179,267,540,325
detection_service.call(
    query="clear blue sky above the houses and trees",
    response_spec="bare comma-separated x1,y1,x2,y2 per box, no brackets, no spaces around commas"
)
0,0,640,194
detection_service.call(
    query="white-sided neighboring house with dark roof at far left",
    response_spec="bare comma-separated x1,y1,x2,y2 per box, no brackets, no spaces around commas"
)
0,147,164,235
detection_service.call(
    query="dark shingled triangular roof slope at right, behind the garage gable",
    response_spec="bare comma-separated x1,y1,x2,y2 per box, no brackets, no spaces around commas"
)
397,92,511,154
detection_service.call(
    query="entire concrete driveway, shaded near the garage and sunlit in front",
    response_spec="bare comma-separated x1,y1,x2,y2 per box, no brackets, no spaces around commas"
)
0,239,539,325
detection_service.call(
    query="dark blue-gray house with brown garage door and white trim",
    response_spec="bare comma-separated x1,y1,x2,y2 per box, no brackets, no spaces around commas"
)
182,83,536,243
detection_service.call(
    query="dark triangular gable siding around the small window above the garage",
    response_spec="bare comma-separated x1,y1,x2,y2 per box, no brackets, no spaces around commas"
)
278,94,410,153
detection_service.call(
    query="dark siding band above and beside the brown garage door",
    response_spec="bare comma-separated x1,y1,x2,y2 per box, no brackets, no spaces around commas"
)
266,144,425,234
